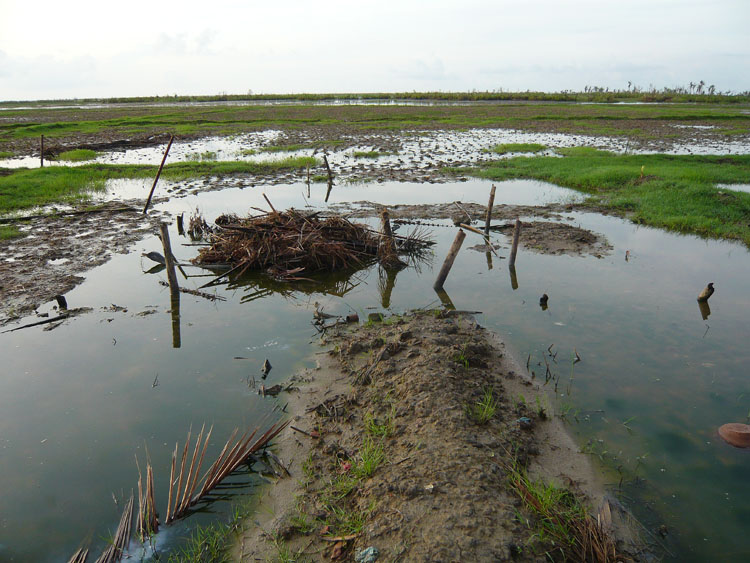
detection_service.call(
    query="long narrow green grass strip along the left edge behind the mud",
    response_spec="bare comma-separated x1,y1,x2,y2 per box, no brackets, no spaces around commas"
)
0,157,318,214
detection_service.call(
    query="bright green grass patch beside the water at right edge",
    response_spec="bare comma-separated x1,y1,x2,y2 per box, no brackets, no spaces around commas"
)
474,151,750,245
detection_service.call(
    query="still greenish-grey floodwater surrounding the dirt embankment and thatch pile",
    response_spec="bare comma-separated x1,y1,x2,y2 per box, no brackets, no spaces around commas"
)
0,180,750,561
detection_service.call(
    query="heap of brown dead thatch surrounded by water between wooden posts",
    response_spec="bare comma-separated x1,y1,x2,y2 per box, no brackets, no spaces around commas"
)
193,209,427,280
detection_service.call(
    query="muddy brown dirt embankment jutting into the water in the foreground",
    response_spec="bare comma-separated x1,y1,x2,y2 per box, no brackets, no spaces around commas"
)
236,311,627,561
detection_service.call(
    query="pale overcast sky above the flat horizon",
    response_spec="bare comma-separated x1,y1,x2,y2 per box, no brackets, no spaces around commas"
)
0,0,750,100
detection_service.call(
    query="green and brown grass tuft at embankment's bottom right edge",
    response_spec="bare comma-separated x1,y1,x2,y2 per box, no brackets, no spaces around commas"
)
506,463,621,562
